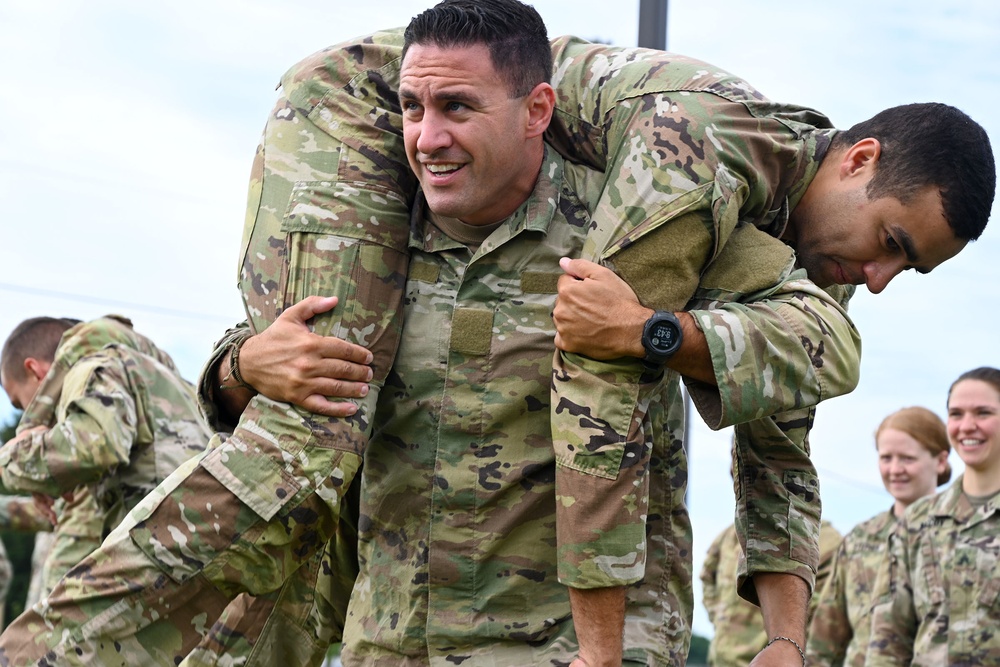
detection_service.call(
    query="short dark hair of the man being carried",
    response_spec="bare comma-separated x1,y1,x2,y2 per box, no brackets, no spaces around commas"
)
834,102,997,241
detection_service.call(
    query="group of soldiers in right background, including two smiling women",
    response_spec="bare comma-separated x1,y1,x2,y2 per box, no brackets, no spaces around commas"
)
701,378,1000,667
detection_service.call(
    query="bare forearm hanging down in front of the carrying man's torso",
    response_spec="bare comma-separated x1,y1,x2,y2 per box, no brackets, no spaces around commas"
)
569,586,625,667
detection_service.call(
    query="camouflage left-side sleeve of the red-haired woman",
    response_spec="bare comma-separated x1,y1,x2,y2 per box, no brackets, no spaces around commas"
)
806,540,854,667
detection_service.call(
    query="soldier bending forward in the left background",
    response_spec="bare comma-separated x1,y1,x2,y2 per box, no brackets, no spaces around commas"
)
0,316,209,620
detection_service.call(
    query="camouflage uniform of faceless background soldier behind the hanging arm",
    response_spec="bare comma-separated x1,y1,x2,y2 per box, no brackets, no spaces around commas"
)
701,521,841,667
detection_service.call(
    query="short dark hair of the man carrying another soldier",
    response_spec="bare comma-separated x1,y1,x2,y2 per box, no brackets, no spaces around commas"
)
403,0,552,97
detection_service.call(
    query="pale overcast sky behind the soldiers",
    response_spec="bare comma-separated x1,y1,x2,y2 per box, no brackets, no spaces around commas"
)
0,0,1000,635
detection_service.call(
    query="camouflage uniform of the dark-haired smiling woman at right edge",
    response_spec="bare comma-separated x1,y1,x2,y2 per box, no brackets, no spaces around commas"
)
865,476,1000,667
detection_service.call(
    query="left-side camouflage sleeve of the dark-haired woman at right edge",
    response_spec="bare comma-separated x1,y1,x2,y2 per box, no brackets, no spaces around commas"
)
865,518,917,667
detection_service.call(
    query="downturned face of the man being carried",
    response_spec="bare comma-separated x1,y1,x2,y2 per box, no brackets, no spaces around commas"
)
792,151,966,294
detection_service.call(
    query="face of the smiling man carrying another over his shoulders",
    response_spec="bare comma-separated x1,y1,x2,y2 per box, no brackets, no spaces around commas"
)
399,44,538,225
